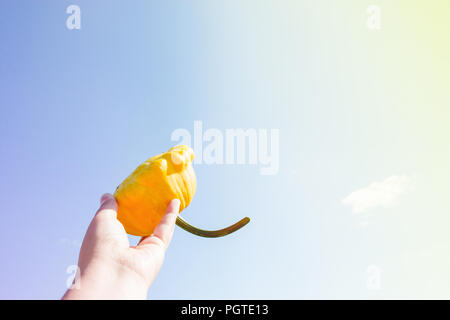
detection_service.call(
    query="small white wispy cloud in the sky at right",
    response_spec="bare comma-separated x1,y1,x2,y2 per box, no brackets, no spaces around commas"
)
342,176,411,213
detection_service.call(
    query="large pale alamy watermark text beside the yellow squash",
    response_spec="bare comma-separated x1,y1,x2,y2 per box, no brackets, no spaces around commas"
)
170,121,280,175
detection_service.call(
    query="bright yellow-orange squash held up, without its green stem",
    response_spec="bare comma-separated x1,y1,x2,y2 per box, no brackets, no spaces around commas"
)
114,145,197,236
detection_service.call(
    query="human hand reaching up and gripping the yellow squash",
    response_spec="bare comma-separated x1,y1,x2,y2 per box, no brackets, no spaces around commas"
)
63,194,180,299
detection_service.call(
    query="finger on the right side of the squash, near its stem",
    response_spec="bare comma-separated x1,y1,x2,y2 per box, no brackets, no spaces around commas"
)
138,199,180,250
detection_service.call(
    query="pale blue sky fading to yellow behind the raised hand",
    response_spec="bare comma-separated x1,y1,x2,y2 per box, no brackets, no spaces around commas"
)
0,0,450,299
